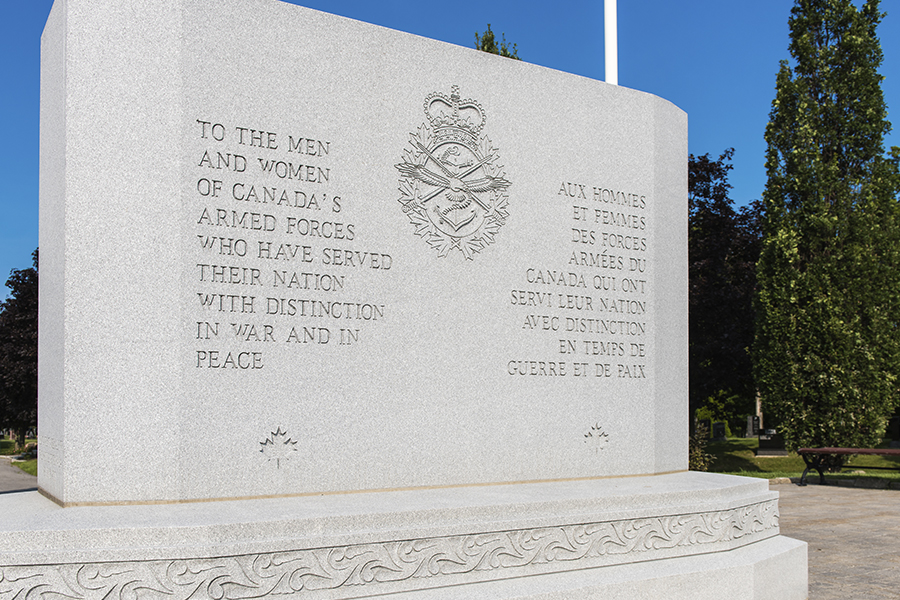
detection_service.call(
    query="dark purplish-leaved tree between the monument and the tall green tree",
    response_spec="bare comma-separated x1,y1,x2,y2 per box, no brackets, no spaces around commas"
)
688,148,760,428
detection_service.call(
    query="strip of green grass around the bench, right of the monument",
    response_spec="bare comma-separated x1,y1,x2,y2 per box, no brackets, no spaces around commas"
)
706,438,900,479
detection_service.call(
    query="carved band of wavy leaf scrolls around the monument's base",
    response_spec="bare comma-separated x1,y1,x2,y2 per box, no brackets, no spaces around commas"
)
0,500,778,600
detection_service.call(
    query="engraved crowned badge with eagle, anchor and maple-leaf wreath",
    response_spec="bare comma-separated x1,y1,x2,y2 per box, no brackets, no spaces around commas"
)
397,86,510,260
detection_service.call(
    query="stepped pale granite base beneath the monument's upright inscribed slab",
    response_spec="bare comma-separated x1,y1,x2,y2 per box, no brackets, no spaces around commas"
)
0,473,806,600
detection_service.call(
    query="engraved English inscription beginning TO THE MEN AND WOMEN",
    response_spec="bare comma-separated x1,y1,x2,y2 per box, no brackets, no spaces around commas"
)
192,119,395,368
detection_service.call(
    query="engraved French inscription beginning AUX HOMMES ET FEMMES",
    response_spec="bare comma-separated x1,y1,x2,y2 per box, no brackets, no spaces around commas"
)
506,180,653,382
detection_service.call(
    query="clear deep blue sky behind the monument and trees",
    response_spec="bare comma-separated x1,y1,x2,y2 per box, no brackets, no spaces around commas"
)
0,0,900,297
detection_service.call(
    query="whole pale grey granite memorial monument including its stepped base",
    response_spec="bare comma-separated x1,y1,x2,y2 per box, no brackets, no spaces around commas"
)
0,0,806,600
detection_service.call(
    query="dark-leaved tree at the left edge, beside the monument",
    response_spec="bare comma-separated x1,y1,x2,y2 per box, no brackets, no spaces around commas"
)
0,250,38,449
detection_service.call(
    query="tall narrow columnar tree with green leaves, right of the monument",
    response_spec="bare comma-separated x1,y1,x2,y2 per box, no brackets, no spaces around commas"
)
754,0,900,449
